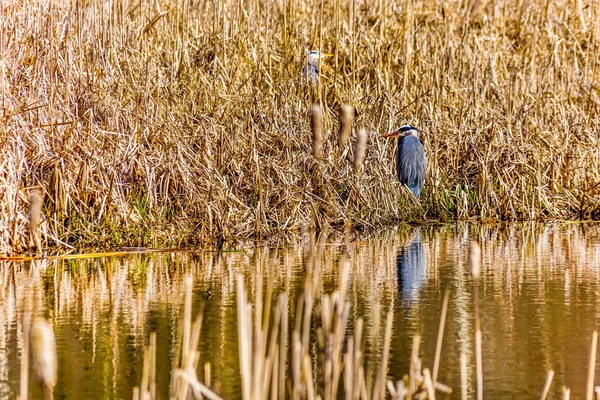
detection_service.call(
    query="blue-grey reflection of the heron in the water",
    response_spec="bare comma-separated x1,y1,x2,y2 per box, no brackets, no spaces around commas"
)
396,227,427,302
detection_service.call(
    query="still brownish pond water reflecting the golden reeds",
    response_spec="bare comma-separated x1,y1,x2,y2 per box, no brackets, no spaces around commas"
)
0,223,600,399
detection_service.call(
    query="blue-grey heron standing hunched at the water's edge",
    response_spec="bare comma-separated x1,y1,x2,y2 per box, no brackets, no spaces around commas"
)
383,125,427,198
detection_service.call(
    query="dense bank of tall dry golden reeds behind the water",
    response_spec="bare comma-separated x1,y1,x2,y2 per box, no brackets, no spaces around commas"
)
0,0,600,253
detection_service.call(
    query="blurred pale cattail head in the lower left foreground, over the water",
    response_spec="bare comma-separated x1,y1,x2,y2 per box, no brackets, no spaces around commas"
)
31,318,56,391
